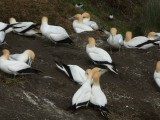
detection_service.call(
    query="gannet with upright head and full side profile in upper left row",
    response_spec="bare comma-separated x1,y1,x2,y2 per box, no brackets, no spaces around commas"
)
40,17,73,44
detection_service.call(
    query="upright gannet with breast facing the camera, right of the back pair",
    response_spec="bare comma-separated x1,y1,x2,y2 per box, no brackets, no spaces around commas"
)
107,28,123,49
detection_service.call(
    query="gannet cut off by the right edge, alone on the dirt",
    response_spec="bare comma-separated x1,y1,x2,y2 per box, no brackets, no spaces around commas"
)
153,61,160,87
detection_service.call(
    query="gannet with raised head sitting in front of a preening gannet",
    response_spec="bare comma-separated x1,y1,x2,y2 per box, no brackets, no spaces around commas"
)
0,49,40,76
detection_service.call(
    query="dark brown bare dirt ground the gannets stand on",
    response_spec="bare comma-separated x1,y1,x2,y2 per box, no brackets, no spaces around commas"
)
0,32,160,120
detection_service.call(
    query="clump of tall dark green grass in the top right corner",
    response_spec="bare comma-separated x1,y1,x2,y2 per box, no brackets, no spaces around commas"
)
136,0,160,35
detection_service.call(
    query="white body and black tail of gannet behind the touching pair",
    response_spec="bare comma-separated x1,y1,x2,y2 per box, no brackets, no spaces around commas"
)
55,61,87,85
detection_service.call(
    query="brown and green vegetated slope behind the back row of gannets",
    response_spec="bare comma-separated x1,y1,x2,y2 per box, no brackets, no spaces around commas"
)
0,0,160,35
